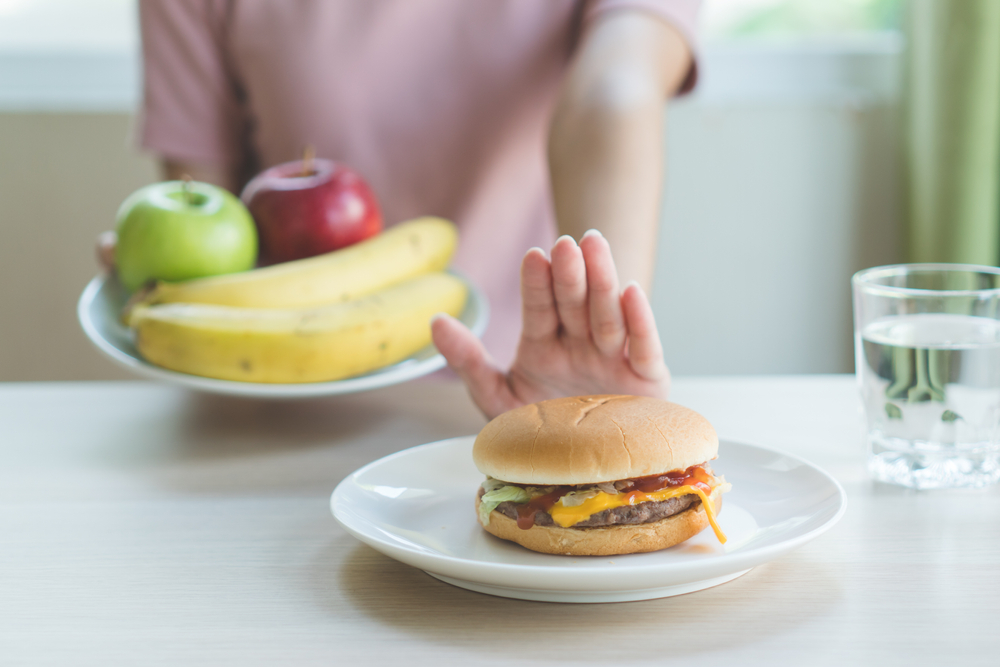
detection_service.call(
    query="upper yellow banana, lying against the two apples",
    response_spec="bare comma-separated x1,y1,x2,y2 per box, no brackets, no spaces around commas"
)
136,217,458,310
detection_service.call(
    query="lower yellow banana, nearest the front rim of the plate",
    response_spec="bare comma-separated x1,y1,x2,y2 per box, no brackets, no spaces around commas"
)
128,273,468,383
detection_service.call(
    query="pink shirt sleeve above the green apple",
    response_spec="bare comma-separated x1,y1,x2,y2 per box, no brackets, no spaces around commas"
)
139,0,246,164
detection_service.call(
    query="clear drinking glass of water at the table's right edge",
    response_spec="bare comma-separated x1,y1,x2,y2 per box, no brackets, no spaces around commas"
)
851,264,1000,489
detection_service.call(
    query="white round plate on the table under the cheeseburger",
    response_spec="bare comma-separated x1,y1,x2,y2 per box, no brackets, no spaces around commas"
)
330,436,847,602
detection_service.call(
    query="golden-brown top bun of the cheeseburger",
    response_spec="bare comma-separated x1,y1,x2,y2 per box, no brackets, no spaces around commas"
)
472,395,719,486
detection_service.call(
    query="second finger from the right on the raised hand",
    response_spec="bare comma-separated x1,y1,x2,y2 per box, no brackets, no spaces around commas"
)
580,229,625,356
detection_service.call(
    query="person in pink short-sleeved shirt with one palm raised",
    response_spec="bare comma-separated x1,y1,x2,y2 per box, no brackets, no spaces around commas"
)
121,0,699,417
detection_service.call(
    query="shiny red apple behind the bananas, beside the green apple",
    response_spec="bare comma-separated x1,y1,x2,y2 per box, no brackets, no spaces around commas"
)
240,153,382,264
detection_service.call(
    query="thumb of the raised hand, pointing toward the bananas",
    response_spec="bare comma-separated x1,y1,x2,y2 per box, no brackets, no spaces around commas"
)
431,313,520,419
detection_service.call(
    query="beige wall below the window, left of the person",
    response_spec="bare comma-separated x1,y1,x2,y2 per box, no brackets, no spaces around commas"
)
0,113,156,381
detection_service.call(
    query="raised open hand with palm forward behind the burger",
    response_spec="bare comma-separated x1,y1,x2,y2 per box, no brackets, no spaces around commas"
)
431,230,670,419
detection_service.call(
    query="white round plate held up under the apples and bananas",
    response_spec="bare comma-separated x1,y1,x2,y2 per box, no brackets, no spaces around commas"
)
76,274,489,398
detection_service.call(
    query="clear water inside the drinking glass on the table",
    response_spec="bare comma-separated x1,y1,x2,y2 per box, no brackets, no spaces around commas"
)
857,313,1000,489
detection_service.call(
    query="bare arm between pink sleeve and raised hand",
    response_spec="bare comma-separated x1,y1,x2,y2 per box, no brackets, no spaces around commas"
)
549,11,691,288
